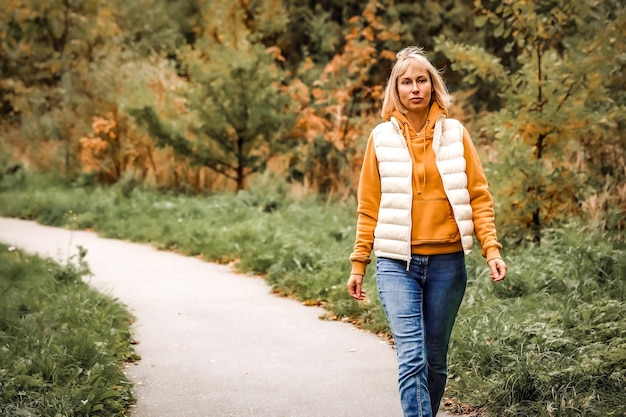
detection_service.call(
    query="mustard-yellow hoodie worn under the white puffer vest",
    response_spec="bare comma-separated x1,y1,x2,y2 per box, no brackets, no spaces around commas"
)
350,102,502,274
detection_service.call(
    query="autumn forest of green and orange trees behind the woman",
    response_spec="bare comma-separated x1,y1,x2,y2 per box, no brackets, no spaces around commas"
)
0,0,626,415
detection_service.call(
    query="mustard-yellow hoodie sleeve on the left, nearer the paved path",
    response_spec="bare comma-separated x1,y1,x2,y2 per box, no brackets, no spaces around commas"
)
350,135,381,275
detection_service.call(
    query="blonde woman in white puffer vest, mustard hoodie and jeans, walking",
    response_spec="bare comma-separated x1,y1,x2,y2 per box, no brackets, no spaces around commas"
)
348,47,506,417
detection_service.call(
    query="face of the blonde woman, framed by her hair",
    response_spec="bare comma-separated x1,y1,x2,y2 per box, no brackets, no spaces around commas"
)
398,63,433,114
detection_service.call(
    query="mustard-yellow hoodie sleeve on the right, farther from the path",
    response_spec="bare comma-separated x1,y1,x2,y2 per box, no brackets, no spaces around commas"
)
463,128,502,260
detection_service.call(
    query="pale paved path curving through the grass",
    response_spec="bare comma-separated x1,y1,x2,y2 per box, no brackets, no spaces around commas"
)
0,218,458,417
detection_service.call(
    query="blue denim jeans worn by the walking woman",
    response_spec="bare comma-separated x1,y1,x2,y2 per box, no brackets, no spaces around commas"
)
376,252,467,417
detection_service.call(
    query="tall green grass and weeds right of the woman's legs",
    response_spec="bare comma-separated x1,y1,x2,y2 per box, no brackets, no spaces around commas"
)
450,225,626,416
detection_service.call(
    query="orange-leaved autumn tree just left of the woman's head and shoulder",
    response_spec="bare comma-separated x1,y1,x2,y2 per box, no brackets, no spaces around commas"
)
290,1,399,193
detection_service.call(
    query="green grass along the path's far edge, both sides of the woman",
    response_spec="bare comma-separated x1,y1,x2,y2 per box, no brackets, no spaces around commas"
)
0,172,626,416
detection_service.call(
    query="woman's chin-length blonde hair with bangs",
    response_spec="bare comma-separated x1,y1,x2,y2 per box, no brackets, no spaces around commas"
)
381,46,452,120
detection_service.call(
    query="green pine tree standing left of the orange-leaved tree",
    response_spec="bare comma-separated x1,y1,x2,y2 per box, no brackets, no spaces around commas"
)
131,1,294,190
